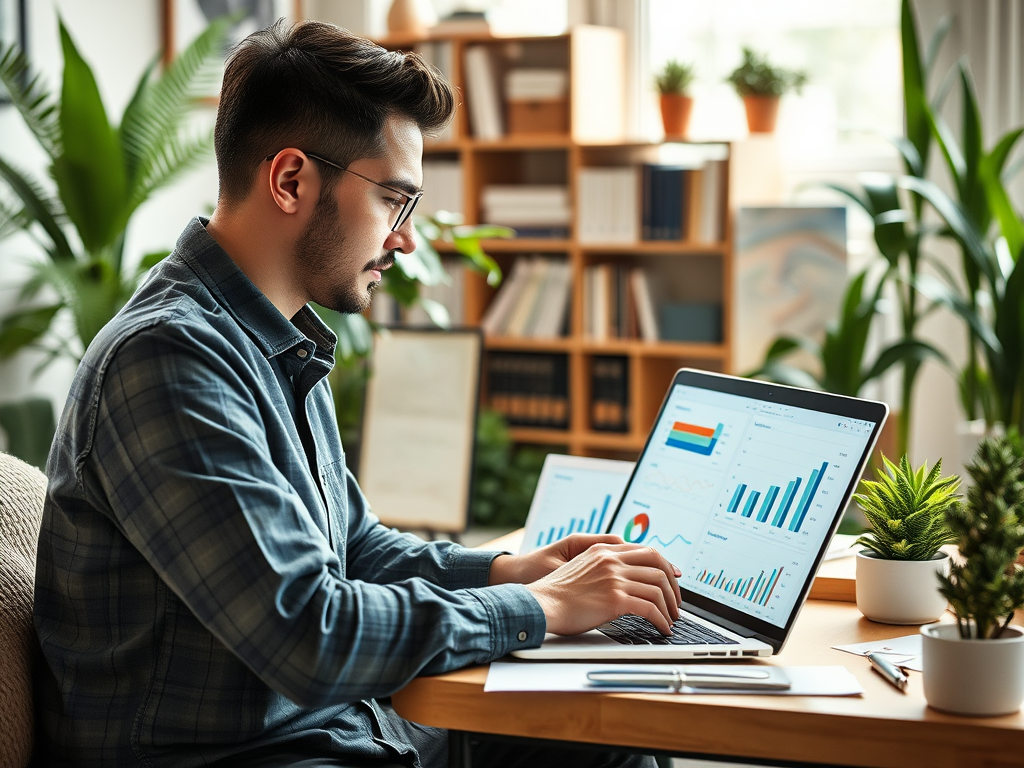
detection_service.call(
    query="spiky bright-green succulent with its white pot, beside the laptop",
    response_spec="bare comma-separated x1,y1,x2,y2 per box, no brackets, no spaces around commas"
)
854,456,959,624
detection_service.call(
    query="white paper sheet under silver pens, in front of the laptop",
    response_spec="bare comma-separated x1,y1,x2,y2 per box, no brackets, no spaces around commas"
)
483,662,864,696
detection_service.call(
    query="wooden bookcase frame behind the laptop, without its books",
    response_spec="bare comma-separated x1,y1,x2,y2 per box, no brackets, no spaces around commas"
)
380,27,733,459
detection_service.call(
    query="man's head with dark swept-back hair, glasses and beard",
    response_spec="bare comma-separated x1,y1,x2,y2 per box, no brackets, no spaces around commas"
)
211,22,455,312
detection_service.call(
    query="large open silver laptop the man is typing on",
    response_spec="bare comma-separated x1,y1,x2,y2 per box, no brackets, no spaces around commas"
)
513,369,889,660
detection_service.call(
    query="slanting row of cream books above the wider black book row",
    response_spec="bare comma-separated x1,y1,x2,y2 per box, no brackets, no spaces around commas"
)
480,256,572,339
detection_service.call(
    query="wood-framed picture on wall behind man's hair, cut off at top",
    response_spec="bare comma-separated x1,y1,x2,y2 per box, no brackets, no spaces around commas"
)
159,0,301,65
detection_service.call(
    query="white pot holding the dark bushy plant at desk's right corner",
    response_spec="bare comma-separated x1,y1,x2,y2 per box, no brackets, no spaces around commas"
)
921,624,1024,715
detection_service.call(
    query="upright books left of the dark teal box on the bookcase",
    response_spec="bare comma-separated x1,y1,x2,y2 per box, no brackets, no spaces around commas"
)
583,263,660,341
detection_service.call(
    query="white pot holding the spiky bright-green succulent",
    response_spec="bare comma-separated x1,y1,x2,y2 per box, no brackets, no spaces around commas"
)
856,550,949,624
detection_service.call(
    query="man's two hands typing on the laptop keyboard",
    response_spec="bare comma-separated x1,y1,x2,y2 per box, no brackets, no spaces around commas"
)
489,535,682,635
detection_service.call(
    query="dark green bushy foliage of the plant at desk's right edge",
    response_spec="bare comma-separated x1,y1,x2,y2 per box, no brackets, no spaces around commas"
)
940,437,1024,640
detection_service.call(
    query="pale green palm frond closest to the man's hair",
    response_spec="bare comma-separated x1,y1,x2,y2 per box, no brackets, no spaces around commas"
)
120,19,229,199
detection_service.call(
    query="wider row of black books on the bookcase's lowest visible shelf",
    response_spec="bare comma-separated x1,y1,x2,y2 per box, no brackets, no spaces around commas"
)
484,352,569,429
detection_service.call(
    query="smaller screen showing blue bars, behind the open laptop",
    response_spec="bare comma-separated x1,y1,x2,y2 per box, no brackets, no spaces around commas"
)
519,454,636,555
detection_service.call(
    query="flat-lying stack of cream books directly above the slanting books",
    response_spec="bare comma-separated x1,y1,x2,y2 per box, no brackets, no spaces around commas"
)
480,184,572,238
